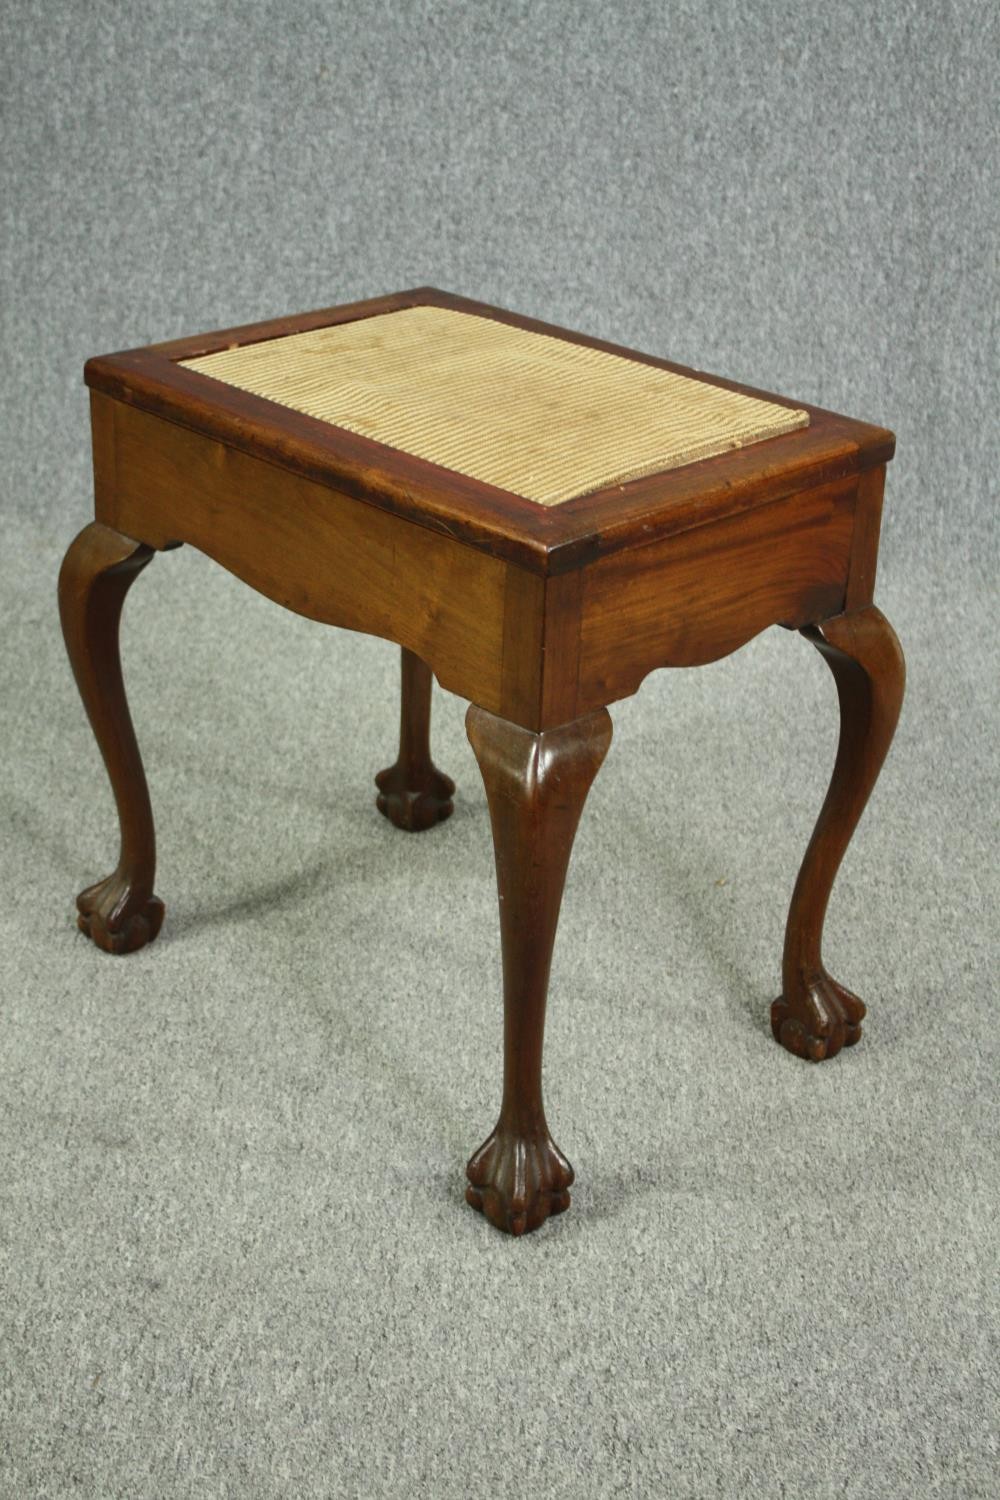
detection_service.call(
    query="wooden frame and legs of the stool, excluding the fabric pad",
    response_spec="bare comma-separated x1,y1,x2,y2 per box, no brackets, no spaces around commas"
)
60,288,903,1233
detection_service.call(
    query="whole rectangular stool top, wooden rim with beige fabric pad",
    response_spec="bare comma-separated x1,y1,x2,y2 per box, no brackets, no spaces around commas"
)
84,287,895,575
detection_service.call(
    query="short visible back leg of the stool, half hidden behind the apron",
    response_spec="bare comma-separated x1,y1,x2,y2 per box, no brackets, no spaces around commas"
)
375,647,454,834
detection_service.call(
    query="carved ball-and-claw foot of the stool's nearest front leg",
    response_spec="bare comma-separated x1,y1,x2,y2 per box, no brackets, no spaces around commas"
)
465,1125,573,1235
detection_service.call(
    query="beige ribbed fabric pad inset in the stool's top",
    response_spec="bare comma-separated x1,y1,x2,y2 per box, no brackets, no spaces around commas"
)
183,306,810,506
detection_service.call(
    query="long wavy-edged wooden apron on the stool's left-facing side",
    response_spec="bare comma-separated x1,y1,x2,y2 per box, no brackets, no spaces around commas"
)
93,396,507,711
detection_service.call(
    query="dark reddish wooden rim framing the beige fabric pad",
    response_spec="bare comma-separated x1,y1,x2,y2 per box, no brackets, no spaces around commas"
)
84,287,895,576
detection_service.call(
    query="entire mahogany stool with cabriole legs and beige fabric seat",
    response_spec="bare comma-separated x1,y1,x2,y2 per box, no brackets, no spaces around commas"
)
58,288,904,1235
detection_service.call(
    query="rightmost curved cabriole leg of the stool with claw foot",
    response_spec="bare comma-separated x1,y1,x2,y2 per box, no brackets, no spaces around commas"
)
771,605,906,1062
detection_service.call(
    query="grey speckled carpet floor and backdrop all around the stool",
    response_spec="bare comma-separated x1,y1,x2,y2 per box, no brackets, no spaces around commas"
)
0,3,1000,1500
